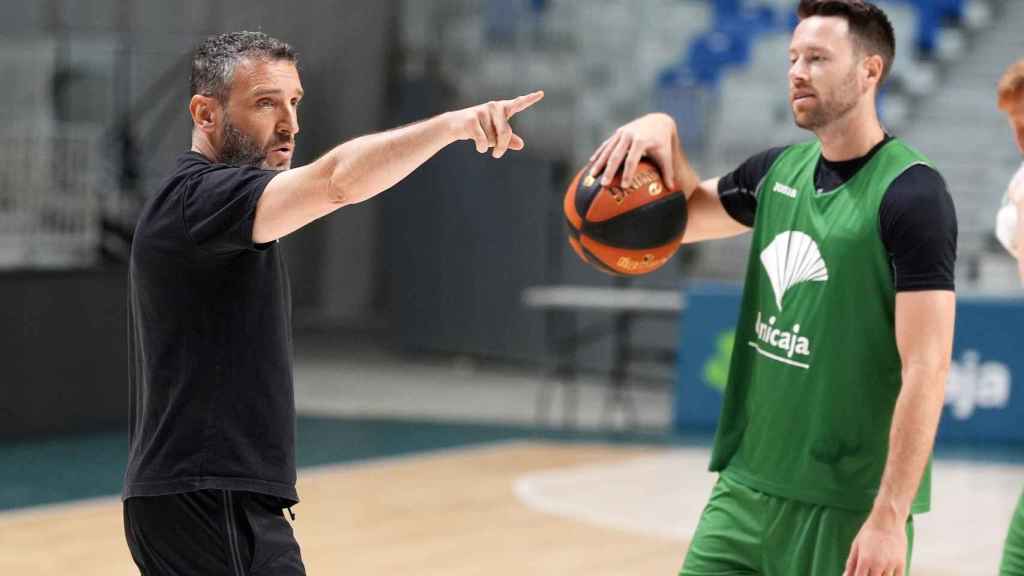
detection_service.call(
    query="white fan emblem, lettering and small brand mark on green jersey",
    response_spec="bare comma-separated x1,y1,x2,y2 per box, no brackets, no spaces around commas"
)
748,228,828,370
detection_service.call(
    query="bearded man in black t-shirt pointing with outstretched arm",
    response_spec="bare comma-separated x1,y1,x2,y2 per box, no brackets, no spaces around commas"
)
123,32,543,576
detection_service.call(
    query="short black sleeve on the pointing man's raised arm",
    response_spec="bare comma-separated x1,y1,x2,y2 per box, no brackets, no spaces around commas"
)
183,164,279,254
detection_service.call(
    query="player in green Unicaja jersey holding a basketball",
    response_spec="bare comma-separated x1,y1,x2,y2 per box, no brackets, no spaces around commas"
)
591,0,956,576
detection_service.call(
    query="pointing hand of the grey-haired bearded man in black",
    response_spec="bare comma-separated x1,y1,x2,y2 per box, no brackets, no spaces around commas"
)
450,90,544,158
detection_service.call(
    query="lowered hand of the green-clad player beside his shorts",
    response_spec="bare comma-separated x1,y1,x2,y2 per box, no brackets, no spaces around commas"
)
843,518,906,576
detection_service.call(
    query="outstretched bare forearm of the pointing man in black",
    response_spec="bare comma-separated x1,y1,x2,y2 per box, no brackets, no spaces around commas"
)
316,114,456,205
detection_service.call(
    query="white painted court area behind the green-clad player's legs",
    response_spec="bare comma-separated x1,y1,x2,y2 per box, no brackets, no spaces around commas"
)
514,448,1024,576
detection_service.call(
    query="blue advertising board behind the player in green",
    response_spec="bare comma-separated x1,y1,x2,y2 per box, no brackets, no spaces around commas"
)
673,286,1024,443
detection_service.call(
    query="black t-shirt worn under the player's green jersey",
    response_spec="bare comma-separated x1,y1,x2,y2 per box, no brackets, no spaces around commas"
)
718,136,956,292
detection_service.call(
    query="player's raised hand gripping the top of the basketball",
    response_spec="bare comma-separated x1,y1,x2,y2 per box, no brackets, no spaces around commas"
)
590,114,677,188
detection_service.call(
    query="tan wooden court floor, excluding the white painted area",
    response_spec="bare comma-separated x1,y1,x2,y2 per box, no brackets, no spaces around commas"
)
0,443,685,576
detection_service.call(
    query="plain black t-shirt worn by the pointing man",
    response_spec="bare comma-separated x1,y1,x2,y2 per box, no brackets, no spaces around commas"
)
124,152,298,502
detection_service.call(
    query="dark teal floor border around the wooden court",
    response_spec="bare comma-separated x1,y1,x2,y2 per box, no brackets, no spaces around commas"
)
0,416,1024,510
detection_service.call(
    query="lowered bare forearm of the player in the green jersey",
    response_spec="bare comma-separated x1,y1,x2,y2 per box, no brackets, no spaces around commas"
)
871,365,948,524
